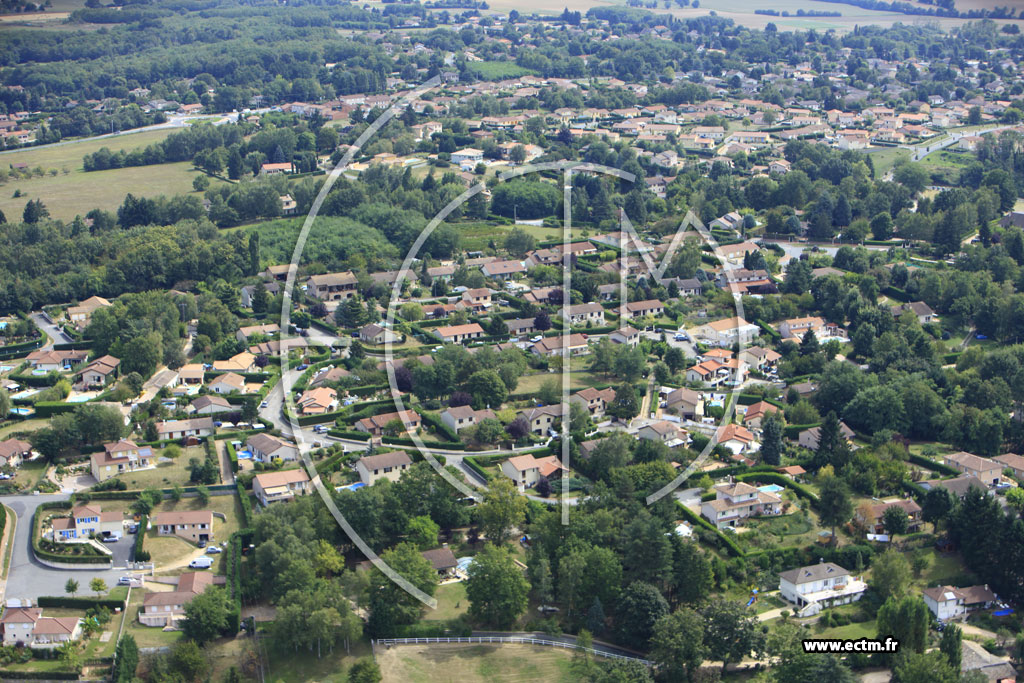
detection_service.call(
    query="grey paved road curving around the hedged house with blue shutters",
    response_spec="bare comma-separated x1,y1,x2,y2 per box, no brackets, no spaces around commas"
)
3,494,126,600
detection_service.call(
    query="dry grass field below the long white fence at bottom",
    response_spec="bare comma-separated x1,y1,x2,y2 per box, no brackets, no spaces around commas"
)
377,644,575,683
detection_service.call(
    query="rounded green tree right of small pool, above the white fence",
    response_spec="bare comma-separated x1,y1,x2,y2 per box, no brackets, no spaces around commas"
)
466,544,529,630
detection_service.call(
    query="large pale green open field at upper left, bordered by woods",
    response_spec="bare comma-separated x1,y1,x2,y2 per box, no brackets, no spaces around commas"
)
0,128,221,220
